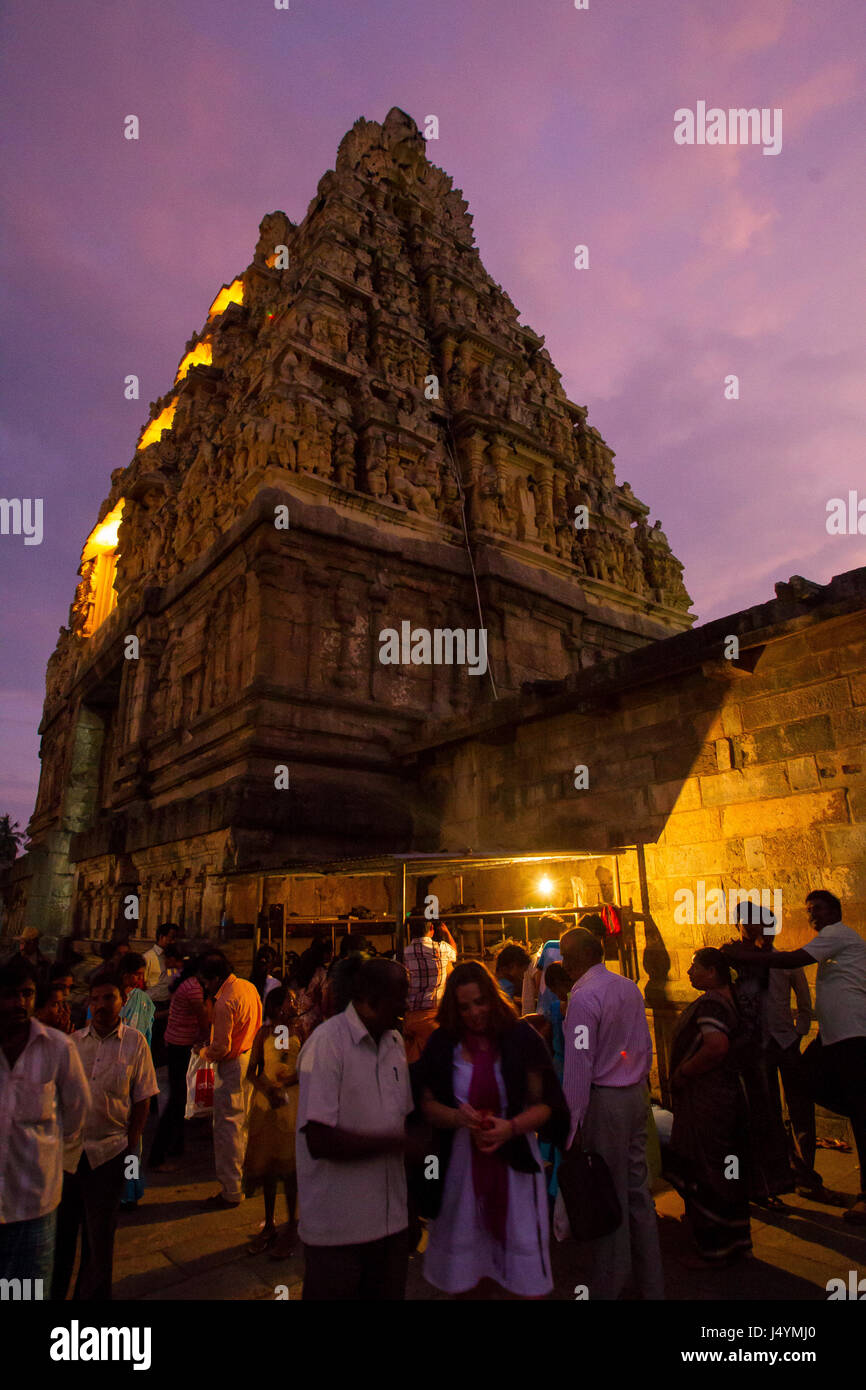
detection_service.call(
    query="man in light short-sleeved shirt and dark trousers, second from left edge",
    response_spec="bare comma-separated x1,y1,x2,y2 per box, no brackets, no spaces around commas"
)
51,970,157,1300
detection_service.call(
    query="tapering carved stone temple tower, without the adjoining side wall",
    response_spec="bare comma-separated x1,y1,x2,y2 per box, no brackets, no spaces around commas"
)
11,108,692,937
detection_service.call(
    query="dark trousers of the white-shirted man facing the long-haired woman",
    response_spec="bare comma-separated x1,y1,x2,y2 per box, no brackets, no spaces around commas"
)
302,1230,409,1302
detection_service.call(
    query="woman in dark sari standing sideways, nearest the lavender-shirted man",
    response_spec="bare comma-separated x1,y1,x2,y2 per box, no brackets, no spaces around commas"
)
664,947,752,1268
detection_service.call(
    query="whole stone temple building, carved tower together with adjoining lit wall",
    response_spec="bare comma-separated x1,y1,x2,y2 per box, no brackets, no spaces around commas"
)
4,108,866,1056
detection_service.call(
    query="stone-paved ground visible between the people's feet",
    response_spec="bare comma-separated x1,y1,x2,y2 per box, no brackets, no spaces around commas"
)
104,1119,866,1302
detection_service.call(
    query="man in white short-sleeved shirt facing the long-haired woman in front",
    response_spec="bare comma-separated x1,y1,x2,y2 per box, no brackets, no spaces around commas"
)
296,959,413,1301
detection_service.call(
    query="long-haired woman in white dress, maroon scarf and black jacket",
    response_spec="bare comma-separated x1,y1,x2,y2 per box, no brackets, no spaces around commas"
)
413,960,569,1298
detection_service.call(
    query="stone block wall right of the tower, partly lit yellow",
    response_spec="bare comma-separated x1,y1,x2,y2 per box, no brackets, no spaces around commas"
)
416,570,866,1084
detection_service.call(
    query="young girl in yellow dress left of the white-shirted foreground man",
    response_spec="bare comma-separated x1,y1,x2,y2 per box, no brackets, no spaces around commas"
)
243,986,300,1259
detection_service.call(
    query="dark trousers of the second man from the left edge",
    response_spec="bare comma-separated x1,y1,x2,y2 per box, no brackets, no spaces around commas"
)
51,1154,125,1301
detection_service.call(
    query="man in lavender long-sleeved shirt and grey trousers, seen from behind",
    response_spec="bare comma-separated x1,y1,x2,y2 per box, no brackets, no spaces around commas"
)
560,927,664,1300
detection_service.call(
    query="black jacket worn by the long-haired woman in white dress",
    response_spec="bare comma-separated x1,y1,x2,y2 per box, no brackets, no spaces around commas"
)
410,1020,571,1220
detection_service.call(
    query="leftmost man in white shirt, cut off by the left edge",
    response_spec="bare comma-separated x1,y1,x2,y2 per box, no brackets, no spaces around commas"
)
0,960,90,1298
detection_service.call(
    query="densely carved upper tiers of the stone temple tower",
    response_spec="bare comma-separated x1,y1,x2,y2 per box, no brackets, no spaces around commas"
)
47,110,689,811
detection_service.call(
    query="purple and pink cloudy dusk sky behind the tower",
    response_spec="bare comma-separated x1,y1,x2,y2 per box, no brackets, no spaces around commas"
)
0,0,866,826
